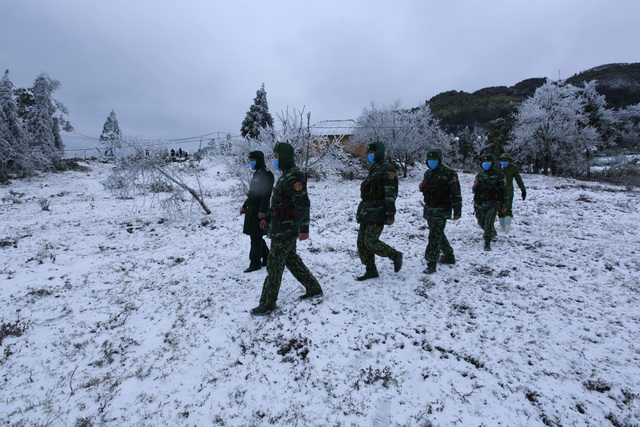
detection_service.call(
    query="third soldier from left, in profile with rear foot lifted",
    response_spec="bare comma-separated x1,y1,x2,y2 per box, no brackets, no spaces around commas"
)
356,141,402,280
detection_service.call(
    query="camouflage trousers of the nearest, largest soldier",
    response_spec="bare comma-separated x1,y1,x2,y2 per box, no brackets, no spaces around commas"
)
260,237,322,307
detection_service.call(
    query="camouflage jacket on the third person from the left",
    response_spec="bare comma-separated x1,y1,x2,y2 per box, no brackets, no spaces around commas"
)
356,161,398,224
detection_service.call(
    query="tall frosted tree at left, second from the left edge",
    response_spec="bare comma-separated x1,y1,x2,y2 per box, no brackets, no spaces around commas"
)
26,73,73,169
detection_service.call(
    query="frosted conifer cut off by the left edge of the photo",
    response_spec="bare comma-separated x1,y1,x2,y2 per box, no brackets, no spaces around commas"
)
0,70,27,182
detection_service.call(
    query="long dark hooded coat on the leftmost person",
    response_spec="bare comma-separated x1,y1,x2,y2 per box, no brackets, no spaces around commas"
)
242,151,274,236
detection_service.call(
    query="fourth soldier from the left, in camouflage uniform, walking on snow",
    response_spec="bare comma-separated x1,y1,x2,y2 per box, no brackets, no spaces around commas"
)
420,149,462,273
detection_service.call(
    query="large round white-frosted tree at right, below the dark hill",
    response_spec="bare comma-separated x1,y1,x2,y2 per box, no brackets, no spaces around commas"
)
506,81,602,176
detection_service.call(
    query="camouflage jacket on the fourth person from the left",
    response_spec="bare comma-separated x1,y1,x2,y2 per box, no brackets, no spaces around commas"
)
420,164,462,219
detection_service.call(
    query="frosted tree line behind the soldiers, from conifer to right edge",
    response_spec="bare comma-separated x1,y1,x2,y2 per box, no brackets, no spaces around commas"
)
240,80,640,181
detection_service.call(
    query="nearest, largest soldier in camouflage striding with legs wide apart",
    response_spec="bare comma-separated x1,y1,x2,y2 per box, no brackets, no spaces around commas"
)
251,143,322,315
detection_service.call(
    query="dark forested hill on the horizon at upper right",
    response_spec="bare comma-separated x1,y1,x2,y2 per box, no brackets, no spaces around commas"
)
427,63,640,132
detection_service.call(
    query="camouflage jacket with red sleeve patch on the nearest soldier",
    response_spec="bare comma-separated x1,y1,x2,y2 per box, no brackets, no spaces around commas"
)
265,166,311,239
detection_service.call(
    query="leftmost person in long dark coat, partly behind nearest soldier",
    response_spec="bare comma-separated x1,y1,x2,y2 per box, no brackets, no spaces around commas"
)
240,151,274,273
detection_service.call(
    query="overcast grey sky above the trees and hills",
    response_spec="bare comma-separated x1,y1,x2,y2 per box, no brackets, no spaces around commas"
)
0,0,640,146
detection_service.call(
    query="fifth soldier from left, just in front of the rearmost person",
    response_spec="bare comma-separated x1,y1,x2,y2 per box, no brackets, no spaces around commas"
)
473,154,508,250
